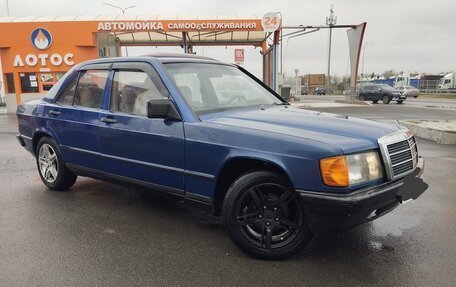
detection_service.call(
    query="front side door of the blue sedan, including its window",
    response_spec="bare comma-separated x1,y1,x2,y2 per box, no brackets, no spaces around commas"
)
100,62,184,195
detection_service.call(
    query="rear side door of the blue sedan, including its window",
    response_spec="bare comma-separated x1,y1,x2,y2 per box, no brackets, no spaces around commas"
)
44,65,109,169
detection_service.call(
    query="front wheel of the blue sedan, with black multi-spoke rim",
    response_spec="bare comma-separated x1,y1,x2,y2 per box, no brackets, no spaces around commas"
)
222,171,312,259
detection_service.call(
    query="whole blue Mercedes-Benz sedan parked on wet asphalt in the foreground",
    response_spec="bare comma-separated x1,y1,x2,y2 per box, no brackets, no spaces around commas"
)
17,54,427,259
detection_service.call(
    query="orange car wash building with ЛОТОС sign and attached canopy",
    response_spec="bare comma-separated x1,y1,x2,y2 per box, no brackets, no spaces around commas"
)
0,16,280,113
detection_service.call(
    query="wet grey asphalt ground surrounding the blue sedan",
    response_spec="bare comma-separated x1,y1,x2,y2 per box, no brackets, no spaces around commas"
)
0,102,456,286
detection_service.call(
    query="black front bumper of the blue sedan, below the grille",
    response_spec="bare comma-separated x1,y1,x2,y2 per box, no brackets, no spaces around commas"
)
297,158,428,235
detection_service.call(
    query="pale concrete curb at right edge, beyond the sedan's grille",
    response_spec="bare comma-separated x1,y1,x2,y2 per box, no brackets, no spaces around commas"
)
403,121,456,144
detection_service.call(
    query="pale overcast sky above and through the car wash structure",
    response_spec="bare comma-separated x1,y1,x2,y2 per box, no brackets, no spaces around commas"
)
0,0,456,76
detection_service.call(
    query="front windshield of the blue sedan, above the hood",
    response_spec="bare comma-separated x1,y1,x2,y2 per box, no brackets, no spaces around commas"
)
165,63,283,114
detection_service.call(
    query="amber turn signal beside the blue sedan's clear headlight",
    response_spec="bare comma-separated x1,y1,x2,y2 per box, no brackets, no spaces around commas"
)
320,156,349,187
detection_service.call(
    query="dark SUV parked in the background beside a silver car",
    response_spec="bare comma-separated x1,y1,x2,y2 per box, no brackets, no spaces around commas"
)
358,84,407,104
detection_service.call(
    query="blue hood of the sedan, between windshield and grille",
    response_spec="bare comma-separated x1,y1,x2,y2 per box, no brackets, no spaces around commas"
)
200,106,398,153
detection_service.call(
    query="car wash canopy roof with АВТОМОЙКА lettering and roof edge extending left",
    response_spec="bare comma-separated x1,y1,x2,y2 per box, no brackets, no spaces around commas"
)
0,15,270,46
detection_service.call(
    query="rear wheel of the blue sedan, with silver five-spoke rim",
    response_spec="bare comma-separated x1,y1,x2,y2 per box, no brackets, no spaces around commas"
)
35,137,77,191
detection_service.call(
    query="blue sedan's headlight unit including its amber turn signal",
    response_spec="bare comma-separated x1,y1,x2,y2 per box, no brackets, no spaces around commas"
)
320,151,383,187
